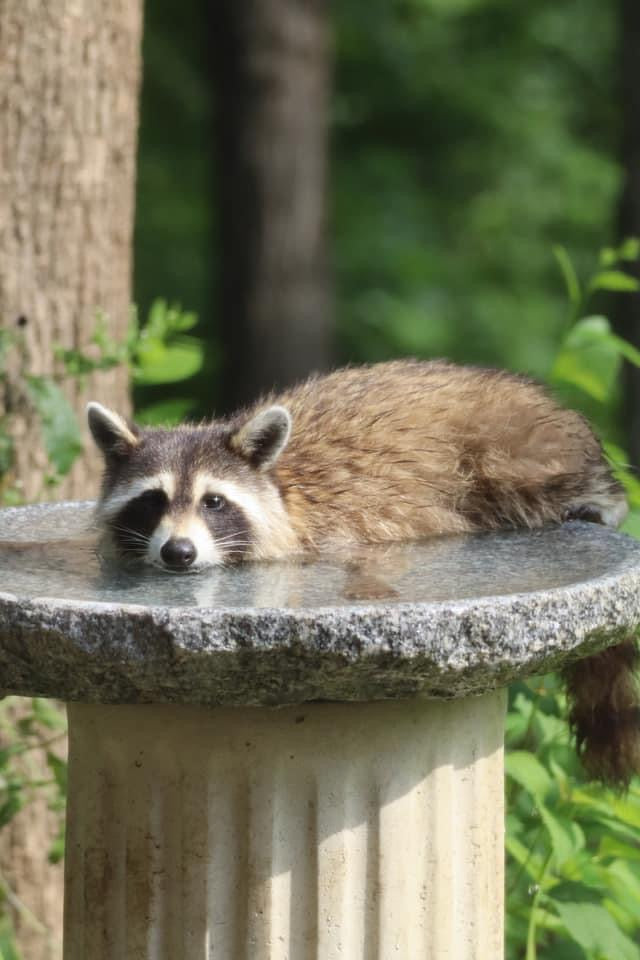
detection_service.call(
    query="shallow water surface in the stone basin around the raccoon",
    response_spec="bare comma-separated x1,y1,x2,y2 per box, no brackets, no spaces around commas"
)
0,503,640,608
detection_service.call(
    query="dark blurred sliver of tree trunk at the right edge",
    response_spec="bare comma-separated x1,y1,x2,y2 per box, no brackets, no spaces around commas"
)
614,0,640,466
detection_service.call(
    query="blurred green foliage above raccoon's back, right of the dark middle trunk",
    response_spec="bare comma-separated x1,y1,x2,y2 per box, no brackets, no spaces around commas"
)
331,0,620,378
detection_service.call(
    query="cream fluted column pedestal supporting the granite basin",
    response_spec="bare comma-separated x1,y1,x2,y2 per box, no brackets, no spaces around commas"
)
64,692,504,960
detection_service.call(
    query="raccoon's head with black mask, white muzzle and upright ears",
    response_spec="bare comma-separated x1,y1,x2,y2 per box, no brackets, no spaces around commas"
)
87,403,295,572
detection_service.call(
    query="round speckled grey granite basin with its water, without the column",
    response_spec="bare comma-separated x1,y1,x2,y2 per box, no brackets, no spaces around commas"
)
0,504,640,705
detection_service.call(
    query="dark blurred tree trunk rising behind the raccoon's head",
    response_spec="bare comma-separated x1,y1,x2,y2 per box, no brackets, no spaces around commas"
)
212,0,333,408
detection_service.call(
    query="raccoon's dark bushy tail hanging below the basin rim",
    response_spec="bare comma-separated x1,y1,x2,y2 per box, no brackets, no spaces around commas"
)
563,636,640,789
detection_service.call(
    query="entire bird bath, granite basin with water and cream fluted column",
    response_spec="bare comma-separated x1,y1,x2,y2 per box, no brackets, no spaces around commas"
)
0,504,640,960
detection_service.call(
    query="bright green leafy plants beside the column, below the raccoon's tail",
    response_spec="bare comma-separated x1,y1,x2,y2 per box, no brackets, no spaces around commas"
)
506,677,640,960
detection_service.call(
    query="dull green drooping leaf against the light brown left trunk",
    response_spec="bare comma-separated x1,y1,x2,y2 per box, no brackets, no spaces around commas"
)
26,376,82,475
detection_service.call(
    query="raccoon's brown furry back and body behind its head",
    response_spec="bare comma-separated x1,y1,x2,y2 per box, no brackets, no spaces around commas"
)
275,361,624,546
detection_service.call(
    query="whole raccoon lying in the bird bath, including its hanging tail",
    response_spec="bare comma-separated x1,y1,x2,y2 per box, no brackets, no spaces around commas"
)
89,361,638,782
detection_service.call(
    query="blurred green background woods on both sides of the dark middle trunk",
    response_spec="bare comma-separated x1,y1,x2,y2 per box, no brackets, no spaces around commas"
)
135,0,622,412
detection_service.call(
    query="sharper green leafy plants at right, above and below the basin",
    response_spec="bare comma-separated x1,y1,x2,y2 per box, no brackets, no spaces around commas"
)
506,239,640,960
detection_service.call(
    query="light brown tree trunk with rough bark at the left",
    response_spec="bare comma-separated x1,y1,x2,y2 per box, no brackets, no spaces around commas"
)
0,0,142,960
